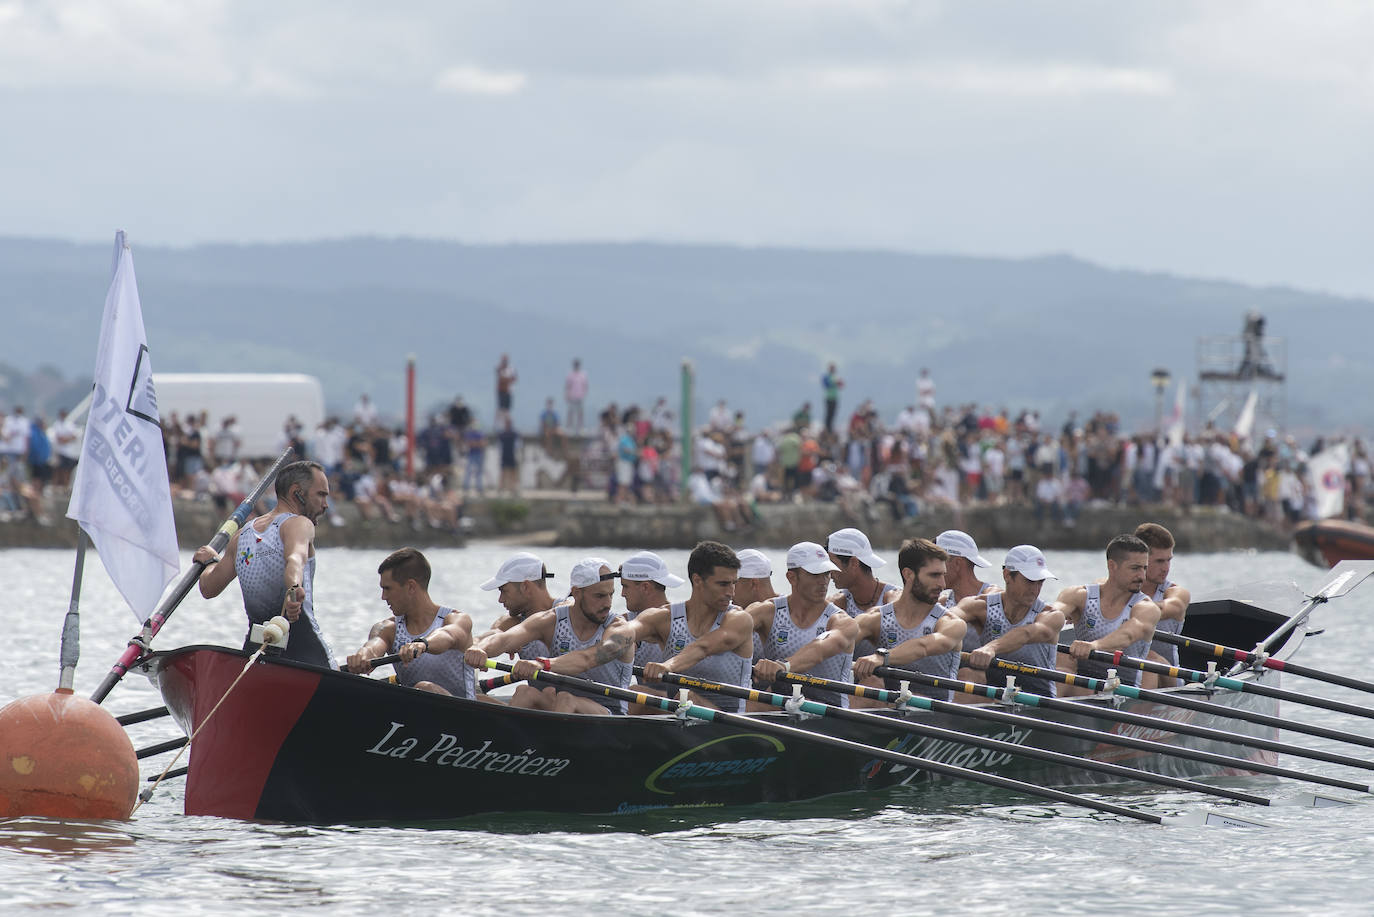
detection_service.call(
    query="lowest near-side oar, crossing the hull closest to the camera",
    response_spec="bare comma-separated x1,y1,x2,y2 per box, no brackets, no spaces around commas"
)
486,659,1259,828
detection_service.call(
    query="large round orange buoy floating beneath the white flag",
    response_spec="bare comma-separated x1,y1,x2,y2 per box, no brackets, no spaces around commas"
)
0,689,139,818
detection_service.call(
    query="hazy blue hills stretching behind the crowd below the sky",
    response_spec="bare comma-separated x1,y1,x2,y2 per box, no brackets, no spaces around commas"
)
0,239,1374,433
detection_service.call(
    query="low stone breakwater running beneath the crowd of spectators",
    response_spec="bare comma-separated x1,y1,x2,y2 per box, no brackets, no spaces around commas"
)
0,491,1292,551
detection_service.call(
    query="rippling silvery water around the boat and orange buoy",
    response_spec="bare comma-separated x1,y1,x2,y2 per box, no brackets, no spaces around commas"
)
0,543,1374,917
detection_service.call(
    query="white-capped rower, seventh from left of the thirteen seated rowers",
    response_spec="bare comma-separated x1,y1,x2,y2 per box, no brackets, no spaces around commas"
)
747,542,859,709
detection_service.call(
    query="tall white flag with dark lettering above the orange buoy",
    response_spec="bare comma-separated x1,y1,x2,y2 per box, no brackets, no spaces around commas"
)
67,232,180,621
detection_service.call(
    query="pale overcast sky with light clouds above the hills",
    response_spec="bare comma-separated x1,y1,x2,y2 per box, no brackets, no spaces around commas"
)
0,0,1374,296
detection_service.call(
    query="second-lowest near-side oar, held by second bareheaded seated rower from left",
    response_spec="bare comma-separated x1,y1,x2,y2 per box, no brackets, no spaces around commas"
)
648,672,1272,806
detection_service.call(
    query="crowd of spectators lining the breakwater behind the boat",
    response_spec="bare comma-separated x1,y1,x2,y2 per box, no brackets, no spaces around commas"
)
0,356,1370,531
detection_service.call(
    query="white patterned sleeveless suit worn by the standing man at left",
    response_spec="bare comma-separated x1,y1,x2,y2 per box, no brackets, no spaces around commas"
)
234,513,334,668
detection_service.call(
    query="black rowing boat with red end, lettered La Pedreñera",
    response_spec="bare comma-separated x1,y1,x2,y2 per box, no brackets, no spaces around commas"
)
139,599,1301,824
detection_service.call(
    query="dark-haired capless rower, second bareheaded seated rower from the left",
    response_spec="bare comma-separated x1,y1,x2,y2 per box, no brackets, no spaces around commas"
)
621,542,753,712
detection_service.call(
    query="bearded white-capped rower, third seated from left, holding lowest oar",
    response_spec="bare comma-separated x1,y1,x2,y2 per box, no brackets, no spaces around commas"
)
464,557,635,714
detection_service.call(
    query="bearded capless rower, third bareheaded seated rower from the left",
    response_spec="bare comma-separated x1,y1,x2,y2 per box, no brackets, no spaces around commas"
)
853,538,965,700
